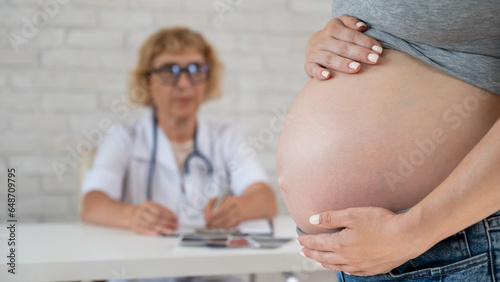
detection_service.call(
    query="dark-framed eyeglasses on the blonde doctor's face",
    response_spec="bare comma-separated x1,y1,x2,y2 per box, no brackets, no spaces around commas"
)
149,63,210,85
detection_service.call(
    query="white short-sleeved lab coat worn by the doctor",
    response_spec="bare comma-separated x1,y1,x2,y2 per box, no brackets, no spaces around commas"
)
82,111,268,225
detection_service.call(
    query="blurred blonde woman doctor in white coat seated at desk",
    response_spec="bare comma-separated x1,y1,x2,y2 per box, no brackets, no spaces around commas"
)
81,28,277,236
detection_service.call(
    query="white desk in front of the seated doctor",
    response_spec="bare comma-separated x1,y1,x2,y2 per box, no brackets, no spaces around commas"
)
0,217,320,282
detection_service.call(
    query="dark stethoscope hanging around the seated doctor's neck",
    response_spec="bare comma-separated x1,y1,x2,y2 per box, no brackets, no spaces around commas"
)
147,110,214,201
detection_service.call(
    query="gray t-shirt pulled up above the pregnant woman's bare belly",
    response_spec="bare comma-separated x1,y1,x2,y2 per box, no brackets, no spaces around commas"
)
332,0,500,94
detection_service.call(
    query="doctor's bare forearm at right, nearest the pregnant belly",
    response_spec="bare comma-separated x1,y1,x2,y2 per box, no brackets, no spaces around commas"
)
240,182,277,220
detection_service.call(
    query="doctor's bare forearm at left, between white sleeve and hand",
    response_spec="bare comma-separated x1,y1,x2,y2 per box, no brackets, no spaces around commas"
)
81,191,137,228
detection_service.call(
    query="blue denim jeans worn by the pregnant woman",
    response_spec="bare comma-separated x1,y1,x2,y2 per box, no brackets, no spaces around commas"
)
337,211,500,282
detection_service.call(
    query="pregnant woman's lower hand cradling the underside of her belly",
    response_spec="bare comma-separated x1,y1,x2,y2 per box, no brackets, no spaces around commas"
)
298,207,426,276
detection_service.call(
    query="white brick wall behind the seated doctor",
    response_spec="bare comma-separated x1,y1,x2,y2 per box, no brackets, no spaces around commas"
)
0,4,330,280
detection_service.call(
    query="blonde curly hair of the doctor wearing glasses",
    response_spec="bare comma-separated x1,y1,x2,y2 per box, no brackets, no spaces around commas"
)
127,27,223,107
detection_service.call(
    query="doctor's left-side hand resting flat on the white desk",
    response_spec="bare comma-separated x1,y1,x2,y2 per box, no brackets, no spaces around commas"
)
130,201,178,236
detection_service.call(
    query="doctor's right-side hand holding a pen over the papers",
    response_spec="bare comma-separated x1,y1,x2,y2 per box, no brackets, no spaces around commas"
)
203,196,243,228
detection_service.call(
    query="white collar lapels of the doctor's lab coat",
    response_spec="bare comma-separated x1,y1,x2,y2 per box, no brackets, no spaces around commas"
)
132,110,211,171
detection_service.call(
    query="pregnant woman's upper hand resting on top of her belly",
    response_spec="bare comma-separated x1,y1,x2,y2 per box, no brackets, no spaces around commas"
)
304,15,383,80
